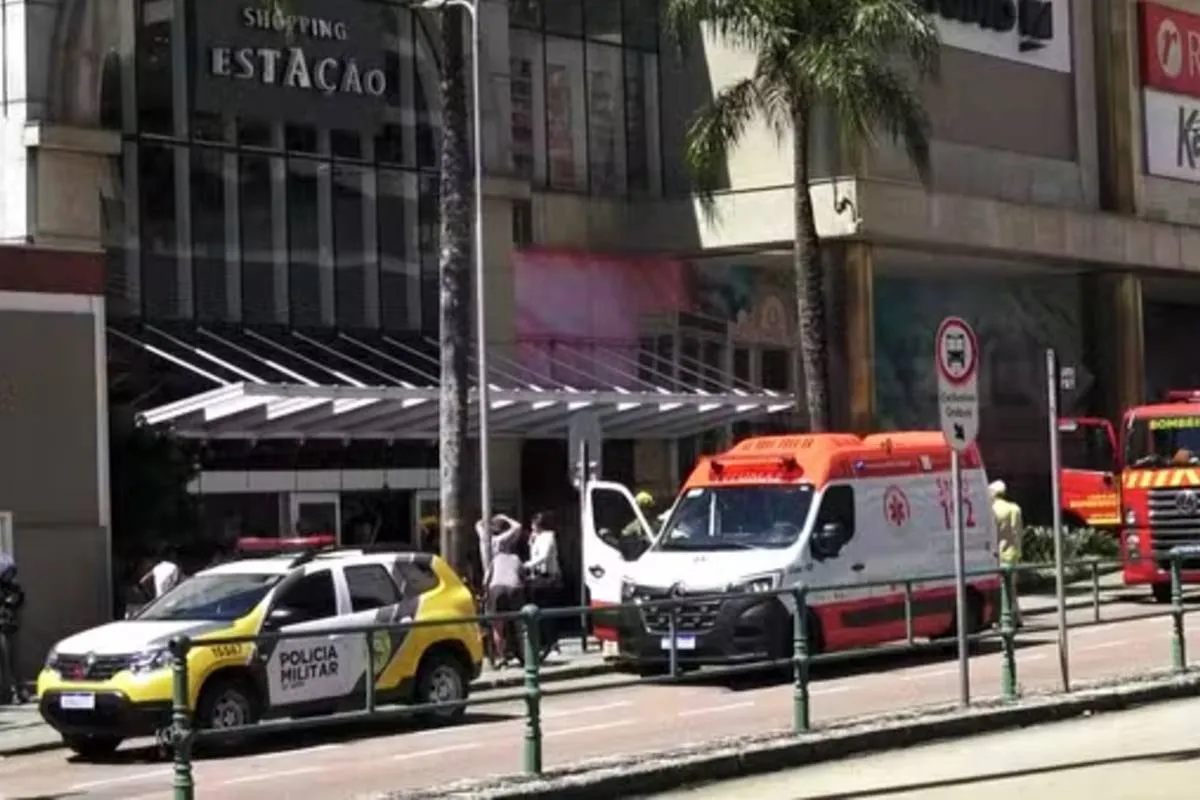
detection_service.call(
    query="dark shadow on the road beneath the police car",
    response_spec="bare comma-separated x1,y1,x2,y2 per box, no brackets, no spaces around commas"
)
65,712,518,767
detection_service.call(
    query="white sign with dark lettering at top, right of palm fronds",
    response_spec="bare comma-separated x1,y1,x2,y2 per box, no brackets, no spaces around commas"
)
920,0,1072,72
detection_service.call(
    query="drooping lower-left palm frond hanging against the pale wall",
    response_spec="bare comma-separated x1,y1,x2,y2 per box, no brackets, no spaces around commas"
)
685,78,761,217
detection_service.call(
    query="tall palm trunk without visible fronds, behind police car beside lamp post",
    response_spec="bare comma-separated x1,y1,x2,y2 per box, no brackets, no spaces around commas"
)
438,7,472,576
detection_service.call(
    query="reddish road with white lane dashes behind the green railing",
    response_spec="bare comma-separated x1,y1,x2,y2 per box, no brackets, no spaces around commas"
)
0,603,1200,800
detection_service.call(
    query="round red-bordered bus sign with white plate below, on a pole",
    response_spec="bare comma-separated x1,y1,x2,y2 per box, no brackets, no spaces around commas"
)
934,317,979,452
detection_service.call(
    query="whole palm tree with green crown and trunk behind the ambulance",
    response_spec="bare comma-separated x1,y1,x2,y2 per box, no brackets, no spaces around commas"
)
666,0,941,432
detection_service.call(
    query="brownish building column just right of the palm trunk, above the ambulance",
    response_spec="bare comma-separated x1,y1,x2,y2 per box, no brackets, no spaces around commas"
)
841,242,875,433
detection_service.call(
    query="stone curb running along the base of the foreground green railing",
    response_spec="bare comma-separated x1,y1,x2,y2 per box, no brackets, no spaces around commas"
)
391,674,1200,800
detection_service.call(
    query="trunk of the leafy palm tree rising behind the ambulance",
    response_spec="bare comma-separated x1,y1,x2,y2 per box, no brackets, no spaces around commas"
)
792,107,829,433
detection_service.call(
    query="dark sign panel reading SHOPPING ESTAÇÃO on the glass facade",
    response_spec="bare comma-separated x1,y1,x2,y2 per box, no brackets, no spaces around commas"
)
192,0,395,130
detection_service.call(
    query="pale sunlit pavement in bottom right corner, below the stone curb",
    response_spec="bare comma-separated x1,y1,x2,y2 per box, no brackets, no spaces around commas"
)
654,699,1200,800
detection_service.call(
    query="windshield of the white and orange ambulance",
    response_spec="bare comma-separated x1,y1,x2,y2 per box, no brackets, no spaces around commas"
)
655,485,812,551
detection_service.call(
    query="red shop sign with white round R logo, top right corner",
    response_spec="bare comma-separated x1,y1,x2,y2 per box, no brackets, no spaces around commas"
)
1140,2,1200,97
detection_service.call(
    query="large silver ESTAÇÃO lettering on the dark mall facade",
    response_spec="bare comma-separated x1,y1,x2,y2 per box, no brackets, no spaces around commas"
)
209,47,388,97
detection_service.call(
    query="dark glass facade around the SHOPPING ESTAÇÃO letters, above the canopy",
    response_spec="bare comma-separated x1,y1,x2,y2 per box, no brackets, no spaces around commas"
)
109,0,440,332
